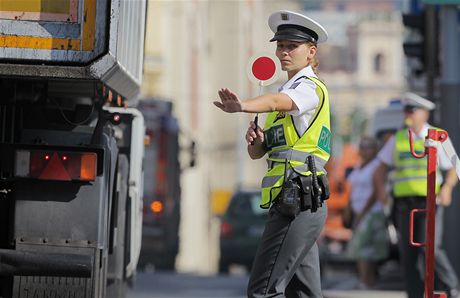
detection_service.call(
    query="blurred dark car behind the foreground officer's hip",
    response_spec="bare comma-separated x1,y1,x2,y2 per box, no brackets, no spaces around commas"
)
219,190,268,273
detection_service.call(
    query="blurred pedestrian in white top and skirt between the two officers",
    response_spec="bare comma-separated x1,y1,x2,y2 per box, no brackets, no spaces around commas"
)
347,137,388,289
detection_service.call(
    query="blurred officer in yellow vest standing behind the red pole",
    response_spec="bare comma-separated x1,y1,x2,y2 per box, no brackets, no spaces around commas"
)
374,93,458,298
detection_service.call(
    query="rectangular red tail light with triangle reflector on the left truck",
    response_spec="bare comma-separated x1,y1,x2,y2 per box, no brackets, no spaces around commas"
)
15,150,97,181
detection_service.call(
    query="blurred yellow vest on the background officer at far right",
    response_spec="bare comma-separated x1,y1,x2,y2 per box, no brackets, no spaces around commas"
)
393,129,440,198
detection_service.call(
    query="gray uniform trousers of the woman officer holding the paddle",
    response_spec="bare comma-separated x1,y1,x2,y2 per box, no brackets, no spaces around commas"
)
247,202,327,298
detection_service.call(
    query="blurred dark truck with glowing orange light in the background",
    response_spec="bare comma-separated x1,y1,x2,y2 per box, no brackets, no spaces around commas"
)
139,98,181,270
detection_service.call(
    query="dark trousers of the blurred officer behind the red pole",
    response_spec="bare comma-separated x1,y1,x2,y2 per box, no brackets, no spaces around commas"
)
394,197,458,298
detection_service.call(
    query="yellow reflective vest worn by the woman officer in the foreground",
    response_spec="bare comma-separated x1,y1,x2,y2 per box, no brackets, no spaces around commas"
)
260,77,331,208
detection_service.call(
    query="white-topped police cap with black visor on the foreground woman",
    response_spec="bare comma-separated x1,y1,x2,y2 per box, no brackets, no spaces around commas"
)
268,10,327,43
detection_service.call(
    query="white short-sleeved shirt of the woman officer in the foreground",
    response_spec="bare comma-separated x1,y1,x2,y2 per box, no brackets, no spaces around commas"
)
278,66,319,136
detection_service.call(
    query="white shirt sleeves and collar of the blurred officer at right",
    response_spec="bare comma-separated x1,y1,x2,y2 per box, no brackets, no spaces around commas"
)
377,123,452,170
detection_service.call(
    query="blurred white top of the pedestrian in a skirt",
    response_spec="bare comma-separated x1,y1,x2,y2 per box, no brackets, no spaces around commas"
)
347,158,383,213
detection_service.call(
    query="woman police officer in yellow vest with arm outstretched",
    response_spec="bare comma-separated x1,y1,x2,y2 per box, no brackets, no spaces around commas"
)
214,11,331,297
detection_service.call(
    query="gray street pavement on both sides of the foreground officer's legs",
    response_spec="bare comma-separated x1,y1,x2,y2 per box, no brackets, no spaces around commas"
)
127,264,406,298
